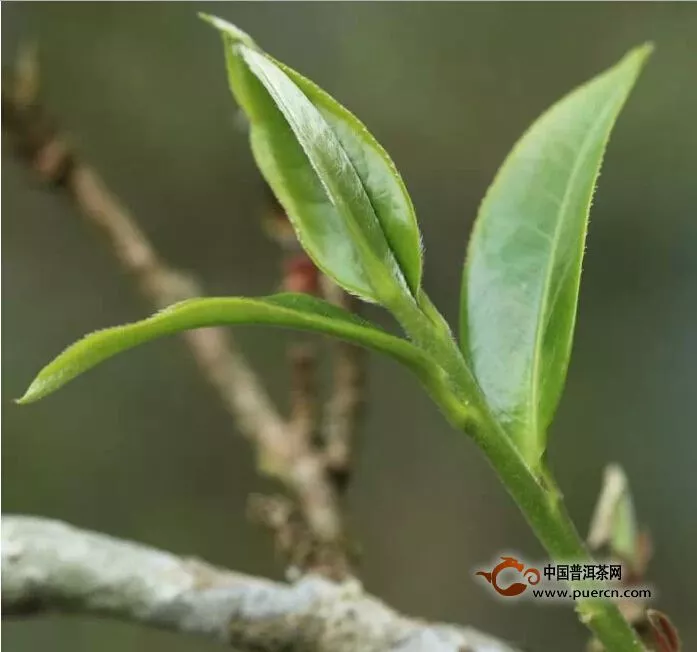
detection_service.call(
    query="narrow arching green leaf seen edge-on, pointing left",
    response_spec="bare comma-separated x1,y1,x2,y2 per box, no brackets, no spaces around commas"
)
18,294,433,403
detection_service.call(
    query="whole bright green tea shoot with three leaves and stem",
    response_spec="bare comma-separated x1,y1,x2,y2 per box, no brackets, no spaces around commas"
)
12,16,664,652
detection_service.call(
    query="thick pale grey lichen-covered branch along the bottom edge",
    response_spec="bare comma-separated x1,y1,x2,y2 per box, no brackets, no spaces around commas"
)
2,516,516,652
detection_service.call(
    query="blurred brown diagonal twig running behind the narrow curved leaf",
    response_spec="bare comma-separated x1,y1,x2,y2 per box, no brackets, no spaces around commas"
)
2,49,346,574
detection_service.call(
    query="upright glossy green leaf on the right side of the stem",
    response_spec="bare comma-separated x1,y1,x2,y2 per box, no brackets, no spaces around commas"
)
461,45,651,468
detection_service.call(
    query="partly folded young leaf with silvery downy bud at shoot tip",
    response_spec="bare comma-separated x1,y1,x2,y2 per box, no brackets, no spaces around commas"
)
205,17,422,307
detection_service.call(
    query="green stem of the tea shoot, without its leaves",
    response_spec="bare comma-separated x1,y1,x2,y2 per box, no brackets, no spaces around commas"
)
393,296,645,652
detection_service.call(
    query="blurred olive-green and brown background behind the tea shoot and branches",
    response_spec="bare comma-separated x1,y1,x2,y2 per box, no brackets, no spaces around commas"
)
2,2,697,652
